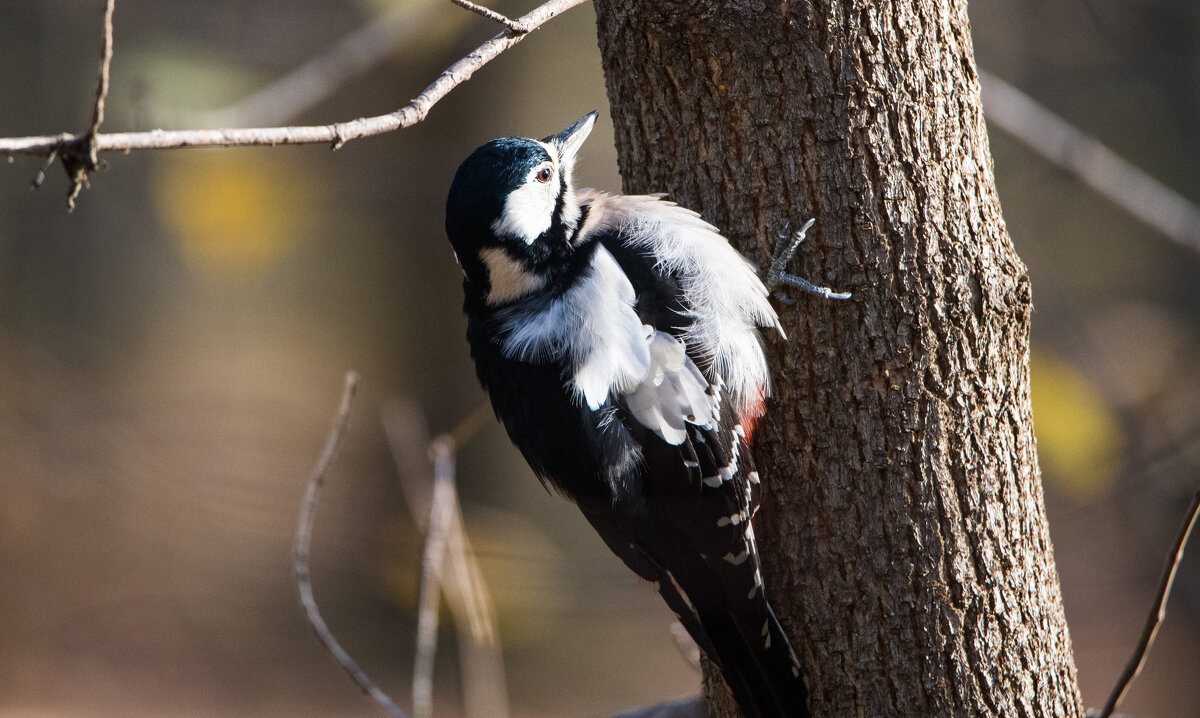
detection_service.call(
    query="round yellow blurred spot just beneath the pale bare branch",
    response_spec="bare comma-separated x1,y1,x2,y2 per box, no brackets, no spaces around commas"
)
155,150,316,277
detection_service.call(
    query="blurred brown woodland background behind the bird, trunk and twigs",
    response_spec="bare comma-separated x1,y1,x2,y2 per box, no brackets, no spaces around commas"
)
0,0,1200,718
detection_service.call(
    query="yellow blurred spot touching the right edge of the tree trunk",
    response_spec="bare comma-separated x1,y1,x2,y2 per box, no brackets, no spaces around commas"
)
1030,352,1122,498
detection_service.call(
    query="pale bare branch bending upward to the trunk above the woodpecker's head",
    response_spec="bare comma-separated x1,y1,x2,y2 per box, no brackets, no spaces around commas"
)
0,0,586,157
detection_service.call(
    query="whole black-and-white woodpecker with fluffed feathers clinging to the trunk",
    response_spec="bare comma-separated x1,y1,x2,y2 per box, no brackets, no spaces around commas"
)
446,112,830,718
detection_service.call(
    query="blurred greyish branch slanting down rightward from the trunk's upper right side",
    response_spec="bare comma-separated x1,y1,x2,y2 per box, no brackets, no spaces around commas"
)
979,70,1200,251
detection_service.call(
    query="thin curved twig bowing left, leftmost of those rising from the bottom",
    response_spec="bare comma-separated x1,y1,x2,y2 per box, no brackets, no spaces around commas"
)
292,371,408,718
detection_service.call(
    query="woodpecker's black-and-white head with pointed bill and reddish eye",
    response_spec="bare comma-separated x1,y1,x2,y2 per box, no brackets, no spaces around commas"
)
446,112,596,305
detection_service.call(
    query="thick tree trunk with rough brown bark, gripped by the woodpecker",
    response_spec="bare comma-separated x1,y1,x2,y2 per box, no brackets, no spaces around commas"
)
595,0,1082,717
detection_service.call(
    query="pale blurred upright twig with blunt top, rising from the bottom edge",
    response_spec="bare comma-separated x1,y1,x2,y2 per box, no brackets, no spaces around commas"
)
413,435,455,718
